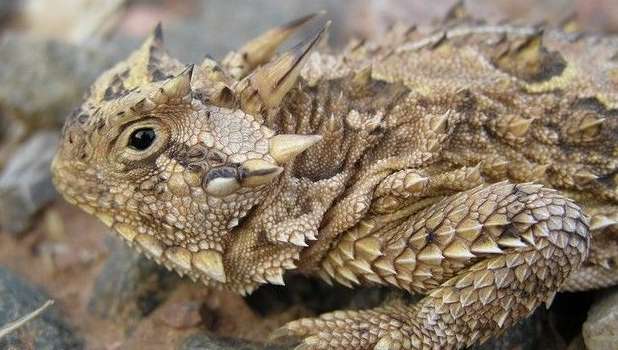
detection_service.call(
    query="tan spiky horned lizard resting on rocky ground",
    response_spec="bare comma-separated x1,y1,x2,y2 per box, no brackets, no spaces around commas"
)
52,10,618,350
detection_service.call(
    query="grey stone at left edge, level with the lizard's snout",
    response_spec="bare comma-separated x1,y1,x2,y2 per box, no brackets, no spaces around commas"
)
0,131,59,234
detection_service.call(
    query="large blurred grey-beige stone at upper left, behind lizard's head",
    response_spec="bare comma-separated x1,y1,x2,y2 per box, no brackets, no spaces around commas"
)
0,33,119,130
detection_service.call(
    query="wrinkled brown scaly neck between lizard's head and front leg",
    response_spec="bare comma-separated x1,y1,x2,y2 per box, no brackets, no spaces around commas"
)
219,75,407,291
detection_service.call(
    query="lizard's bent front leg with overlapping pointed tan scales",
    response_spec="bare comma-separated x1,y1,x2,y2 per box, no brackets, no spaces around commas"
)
279,182,589,350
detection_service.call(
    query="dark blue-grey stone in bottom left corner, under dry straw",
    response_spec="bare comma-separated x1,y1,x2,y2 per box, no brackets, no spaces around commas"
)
0,267,84,350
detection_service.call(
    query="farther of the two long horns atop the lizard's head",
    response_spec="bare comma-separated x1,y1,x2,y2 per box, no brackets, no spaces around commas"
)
222,12,323,79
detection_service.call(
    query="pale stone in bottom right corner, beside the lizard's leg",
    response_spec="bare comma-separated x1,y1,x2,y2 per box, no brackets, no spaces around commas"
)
582,288,618,350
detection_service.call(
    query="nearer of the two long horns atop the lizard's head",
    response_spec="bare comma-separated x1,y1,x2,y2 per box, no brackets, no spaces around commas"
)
236,22,330,114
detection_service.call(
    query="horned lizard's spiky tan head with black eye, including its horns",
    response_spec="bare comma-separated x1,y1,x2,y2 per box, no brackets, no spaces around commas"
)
52,18,323,283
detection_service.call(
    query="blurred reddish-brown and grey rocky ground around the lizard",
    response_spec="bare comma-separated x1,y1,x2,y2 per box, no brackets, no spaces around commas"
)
0,0,618,350
